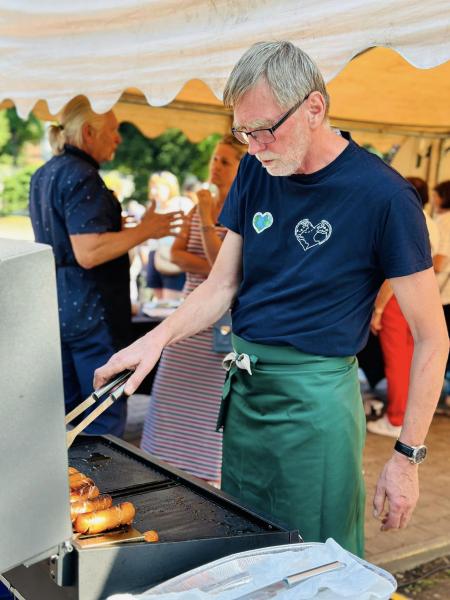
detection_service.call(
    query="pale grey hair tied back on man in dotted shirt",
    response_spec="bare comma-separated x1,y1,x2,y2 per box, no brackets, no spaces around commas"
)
48,96,107,155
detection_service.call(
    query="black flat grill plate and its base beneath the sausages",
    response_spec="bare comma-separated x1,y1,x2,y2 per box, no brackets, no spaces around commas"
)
4,436,299,600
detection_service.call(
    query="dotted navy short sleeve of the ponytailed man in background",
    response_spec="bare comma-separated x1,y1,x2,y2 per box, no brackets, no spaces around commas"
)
64,170,115,235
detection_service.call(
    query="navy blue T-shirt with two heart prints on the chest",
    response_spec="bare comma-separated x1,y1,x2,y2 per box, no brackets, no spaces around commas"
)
219,141,432,356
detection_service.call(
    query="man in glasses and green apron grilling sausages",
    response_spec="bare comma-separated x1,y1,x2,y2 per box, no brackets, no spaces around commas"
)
95,42,448,555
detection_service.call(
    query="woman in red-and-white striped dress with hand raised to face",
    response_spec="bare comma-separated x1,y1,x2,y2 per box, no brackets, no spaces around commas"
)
141,135,246,482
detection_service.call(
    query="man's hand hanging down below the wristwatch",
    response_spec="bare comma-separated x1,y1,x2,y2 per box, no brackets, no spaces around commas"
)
373,453,419,531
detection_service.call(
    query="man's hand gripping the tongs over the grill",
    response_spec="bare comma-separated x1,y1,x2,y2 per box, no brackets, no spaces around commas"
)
94,332,163,396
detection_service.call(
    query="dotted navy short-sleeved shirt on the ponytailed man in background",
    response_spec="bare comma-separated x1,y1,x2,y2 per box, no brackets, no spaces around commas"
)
30,145,131,347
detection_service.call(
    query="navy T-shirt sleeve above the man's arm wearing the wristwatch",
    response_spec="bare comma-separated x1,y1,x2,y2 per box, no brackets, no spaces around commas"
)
377,187,433,279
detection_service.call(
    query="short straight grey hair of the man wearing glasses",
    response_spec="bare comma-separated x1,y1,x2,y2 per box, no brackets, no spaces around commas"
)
223,41,330,112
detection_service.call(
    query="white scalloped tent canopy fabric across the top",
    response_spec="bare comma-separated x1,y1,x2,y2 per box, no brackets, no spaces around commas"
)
0,0,450,118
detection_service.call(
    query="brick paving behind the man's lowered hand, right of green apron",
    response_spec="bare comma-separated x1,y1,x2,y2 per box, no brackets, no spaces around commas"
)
364,415,450,571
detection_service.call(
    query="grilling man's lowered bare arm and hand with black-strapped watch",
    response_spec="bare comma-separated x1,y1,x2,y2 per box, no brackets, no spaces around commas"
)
373,268,449,530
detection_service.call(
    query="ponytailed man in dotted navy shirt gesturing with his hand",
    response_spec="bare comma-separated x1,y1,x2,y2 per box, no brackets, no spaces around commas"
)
30,96,179,436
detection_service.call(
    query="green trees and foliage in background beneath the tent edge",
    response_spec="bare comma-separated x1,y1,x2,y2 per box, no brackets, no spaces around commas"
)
0,108,220,216
